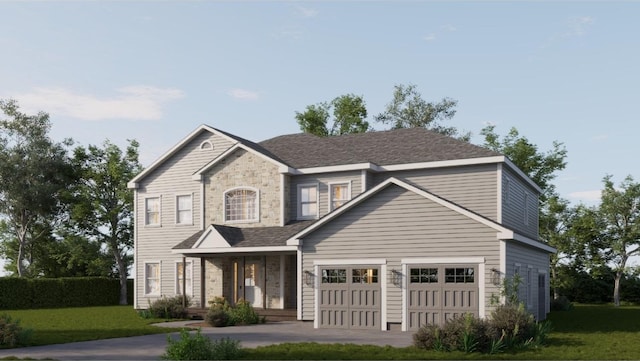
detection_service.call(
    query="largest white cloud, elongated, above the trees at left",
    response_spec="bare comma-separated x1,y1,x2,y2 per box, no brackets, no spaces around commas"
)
15,85,185,121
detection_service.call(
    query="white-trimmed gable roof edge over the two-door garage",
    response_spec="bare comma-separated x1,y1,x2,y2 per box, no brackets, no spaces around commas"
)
286,177,556,253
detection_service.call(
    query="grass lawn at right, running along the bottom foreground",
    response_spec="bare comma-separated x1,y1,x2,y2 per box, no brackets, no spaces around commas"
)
244,305,640,360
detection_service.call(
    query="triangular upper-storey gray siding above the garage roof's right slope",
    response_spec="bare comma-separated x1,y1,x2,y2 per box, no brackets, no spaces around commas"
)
375,164,498,221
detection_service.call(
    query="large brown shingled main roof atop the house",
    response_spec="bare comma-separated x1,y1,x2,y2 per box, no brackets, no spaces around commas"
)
254,128,501,168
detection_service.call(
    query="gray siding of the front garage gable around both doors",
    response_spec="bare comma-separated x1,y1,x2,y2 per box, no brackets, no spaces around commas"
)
302,185,500,323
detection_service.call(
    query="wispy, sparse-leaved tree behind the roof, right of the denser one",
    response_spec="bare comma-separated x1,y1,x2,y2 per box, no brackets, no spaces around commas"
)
375,84,464,141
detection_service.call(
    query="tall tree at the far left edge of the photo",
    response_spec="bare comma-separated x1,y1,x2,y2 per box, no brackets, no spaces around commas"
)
0,100,74,277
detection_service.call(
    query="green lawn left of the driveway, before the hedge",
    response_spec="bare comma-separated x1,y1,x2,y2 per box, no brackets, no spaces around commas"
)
0,306,179,346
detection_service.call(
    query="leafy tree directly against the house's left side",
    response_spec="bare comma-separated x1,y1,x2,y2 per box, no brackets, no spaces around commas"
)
71,140,142,305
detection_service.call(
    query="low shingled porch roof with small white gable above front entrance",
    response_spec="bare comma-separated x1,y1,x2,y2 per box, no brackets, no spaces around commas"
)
173,221,315,250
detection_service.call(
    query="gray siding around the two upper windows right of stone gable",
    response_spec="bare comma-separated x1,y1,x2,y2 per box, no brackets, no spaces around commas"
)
289,170,362,219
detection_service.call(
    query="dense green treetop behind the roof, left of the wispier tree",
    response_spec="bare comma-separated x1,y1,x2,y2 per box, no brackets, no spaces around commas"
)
295,94,370,137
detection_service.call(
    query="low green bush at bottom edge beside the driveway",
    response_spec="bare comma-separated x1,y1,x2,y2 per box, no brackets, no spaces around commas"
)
162,330,242,360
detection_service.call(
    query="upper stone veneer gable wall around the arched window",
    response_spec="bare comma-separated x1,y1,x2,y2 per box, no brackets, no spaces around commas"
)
205,149,281,227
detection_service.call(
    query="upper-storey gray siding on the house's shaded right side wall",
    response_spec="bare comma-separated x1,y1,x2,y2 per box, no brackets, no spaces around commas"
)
502,167,539,240
